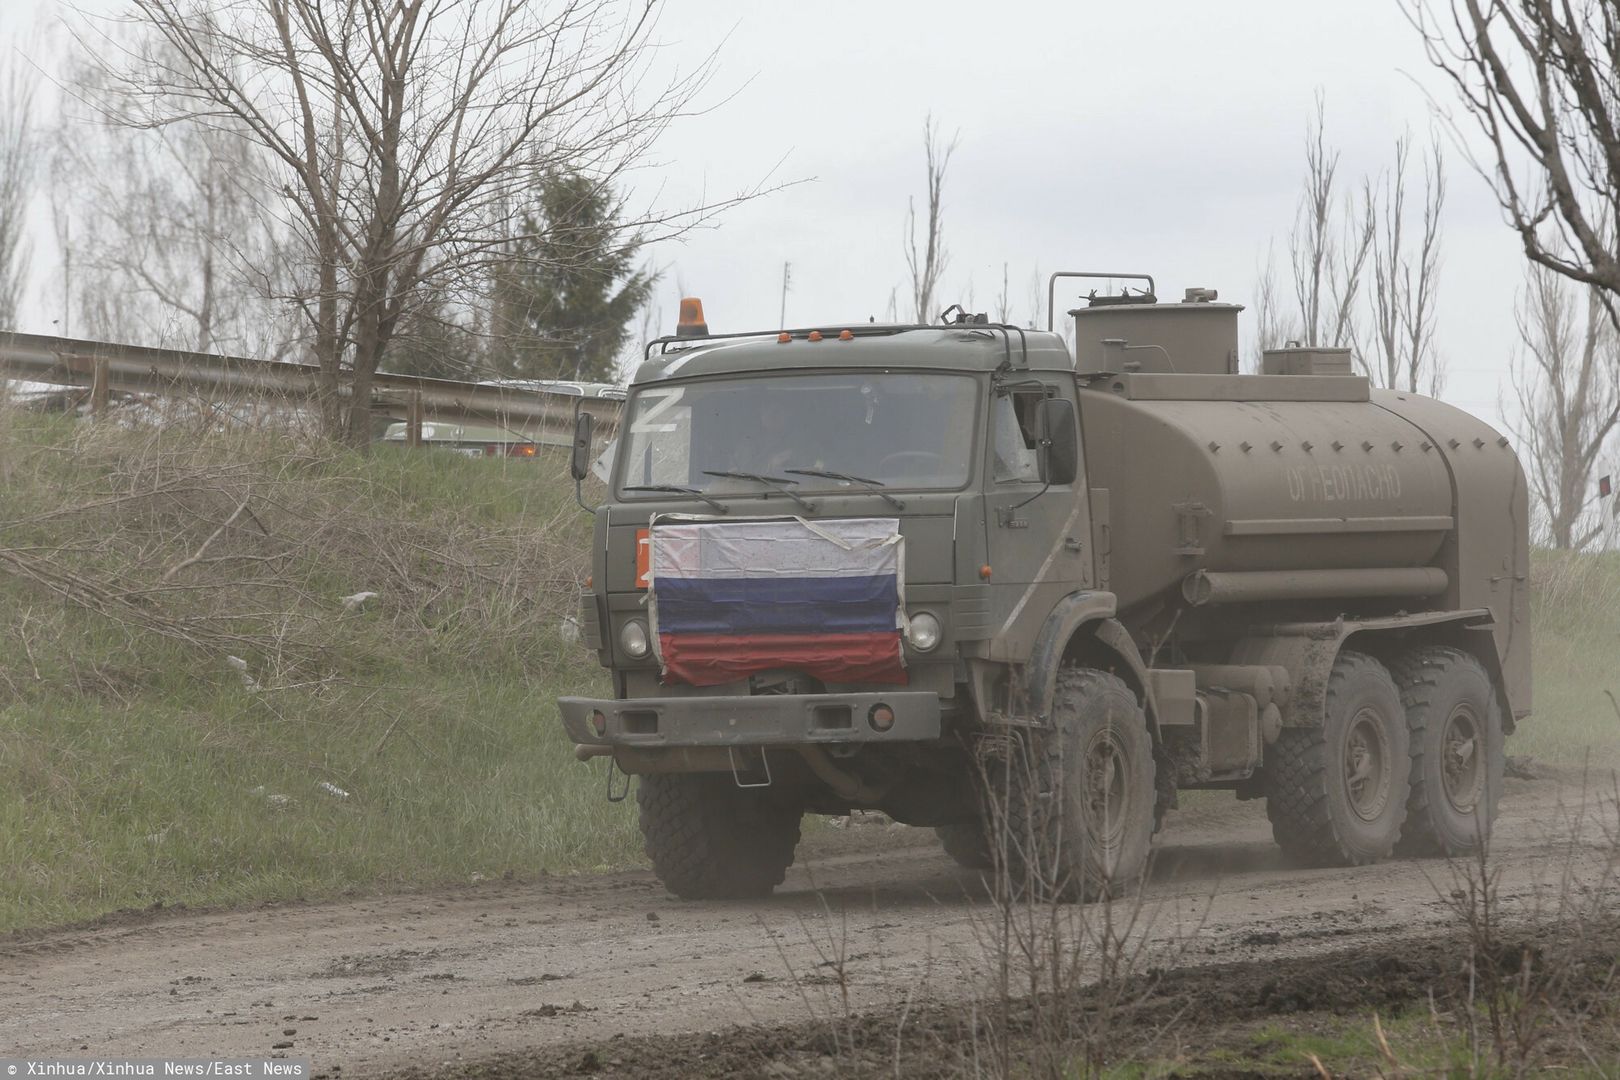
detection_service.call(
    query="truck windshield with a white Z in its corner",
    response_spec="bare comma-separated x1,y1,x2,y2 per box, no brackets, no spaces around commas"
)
619,372,978,494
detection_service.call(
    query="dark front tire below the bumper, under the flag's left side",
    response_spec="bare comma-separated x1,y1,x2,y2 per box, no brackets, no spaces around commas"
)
635,772,800,900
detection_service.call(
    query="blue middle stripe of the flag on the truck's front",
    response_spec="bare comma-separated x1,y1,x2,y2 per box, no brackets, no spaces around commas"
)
653,573,899,633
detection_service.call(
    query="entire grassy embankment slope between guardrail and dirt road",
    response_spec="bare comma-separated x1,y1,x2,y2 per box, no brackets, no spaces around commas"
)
0,415,642,931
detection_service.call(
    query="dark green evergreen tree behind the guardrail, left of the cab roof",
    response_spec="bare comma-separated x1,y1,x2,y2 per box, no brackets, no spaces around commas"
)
489,173,658,382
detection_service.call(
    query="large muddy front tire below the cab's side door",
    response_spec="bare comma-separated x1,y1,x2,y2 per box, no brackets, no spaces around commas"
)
996,667,1158,900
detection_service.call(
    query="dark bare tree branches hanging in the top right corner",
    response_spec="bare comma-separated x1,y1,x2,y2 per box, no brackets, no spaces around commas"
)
1401,0,1620,321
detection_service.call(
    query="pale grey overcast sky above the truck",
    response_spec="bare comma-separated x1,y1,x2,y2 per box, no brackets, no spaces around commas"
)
0,0,1523,430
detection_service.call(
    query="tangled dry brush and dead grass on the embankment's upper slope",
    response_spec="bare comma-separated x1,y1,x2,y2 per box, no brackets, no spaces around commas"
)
0,403,588,680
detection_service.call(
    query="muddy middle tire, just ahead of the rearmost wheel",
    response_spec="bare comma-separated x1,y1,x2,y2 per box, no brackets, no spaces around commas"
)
1265,651,1411,866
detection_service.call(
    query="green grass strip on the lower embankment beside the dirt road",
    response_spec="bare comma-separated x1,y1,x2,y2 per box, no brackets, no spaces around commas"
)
0,674,640,929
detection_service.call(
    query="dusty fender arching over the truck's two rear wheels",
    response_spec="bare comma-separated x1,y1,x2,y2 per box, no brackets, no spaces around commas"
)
1231,609,1513,730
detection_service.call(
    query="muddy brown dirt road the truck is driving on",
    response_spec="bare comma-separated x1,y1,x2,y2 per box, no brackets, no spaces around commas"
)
0,780,1607,1077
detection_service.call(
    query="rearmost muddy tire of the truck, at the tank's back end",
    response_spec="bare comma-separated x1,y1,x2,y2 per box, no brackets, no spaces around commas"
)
1390,646,1505,855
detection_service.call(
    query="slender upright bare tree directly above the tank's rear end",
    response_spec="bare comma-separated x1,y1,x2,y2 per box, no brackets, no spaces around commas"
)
1367,134,1445,393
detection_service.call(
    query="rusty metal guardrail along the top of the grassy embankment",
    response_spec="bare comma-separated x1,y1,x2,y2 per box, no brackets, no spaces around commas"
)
0,334,620,442
